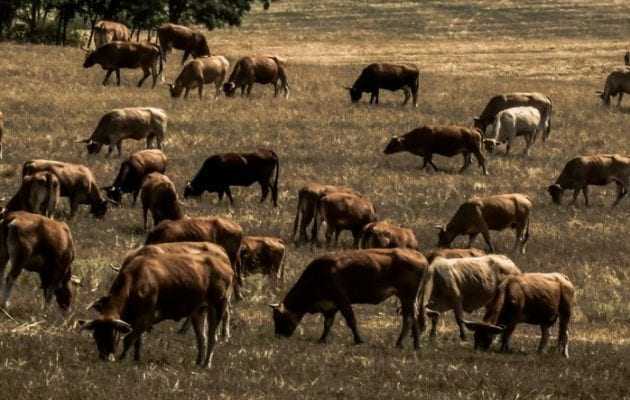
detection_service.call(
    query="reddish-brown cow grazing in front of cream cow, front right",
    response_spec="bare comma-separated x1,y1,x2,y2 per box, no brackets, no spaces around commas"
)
464,273,575,358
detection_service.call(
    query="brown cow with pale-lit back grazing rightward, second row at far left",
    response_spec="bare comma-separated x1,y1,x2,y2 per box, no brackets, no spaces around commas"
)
22,160,108,219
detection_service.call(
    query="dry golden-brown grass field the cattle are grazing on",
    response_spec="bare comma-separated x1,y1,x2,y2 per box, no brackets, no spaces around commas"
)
0,0,630,400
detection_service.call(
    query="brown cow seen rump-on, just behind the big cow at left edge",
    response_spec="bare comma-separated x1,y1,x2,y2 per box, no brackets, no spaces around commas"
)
2,171,61,218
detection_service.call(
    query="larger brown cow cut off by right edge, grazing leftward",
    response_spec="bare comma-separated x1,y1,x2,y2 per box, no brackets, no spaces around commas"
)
547,154,630,207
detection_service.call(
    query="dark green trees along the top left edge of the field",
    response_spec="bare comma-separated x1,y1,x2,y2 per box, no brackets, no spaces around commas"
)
0,0,272,45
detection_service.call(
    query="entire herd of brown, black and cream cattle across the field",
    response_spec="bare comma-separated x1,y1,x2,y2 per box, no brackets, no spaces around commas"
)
0,22,630,367
